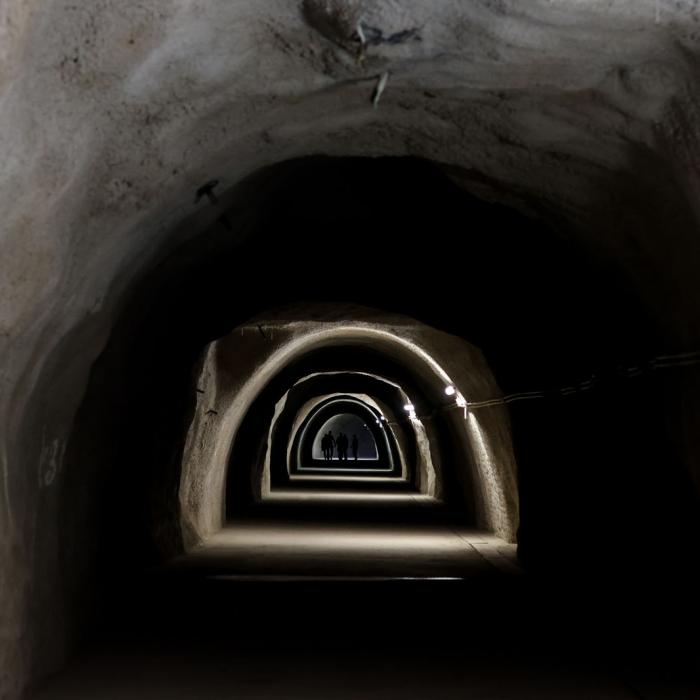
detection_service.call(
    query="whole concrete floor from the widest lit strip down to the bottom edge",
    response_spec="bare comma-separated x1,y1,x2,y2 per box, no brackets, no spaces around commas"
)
27,517,700,700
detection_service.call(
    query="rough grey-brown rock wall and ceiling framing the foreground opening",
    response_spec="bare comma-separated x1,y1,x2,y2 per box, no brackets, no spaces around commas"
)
0,0,700,697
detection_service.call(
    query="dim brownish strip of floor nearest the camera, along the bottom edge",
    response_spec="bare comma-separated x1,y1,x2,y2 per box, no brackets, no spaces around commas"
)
34,630,698,700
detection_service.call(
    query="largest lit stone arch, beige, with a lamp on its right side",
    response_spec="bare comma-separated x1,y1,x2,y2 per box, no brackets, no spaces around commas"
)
180,307,518,542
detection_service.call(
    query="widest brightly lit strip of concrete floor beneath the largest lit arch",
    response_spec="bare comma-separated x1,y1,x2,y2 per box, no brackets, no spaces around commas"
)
173,519,520,579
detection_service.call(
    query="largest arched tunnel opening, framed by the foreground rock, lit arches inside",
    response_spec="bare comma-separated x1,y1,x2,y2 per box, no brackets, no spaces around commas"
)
21,157,697,700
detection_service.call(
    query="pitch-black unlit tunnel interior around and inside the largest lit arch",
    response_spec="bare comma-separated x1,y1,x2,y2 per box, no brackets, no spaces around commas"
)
52,157,700,697
